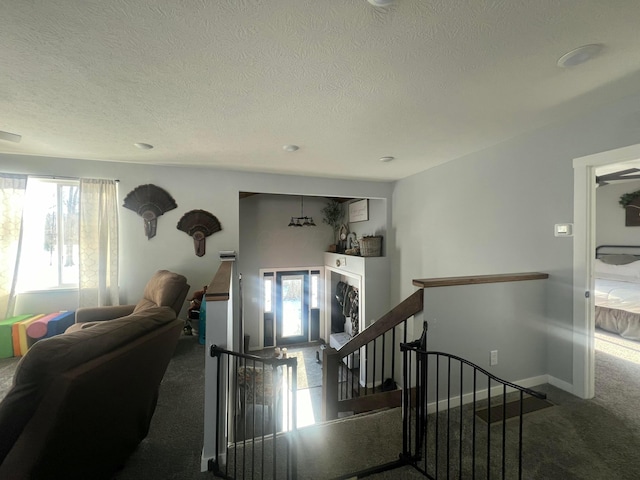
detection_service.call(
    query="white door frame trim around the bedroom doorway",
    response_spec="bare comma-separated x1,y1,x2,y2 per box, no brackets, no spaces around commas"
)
572,144,640,398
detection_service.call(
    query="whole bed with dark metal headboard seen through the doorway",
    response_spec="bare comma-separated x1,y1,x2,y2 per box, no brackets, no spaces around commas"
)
594,245,640,340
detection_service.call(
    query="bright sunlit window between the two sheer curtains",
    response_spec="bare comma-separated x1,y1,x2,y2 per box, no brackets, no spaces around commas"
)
17,178,80,292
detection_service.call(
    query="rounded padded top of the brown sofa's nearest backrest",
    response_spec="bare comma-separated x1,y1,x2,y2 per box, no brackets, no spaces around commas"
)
0,307,175,463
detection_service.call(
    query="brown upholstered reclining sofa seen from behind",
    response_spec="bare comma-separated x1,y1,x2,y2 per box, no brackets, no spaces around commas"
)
0,271,189,480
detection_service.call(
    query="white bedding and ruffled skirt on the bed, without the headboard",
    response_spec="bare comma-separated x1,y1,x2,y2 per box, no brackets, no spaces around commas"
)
595,260,640,340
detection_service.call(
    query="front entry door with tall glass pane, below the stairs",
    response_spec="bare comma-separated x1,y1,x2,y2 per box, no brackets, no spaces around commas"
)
276,270,309,345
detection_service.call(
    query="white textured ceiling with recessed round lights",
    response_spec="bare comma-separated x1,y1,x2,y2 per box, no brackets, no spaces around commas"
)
0,0,640,180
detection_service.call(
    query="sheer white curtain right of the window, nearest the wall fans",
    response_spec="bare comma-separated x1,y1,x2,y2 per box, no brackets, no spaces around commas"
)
79,179,120,307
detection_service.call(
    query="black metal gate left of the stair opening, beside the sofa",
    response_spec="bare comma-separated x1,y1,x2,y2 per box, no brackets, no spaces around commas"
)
209,345,298,480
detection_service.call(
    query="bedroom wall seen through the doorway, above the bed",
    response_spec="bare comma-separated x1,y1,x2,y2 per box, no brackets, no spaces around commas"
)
596,181,640,245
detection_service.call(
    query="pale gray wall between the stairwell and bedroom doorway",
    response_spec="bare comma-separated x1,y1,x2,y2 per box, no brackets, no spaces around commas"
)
390,88,640,384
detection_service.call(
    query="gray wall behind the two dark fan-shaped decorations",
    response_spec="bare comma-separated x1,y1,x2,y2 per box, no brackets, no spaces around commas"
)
0,154,392,320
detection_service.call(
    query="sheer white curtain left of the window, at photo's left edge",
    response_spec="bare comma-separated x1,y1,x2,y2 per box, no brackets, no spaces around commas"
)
0,173,27,318
